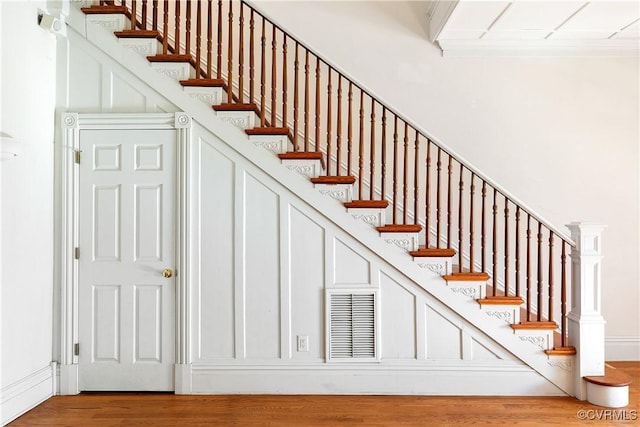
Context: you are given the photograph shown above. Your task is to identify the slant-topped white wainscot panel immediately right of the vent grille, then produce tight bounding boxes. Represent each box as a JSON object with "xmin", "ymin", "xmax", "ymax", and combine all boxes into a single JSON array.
[{"xmin": 380, "ymin": 274, "xmax": 416, "ymax": 359}]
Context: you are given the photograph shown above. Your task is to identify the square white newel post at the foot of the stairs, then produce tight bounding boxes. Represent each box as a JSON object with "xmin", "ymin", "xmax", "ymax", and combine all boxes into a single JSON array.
[{"xmin": 567, "ymin": 222, "xmax": 606, "ymax": 400}]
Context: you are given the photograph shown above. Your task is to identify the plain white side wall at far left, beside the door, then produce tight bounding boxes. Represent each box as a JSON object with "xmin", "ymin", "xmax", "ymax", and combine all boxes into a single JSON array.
[{"xmin": 0, "ymin": 2, "xmax": 55, "ymax": 423}]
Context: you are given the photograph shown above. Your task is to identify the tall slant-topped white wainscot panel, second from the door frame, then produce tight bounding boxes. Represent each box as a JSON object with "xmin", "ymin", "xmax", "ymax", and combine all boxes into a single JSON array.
[{"xmin": 245, "ymin": 173, "xmax": 280, "ymax": 359}]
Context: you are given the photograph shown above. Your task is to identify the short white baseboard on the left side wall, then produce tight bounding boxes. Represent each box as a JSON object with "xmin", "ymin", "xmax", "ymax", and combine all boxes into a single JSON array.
[{"xmin": 0, "ymin": 364, "xmax": 55, "ymax": 425}]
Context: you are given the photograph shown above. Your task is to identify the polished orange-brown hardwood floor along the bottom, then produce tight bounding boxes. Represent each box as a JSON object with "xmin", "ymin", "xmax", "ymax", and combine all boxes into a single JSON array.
[{"xmin": 9, "ymin": 362, "xmax": 640, "ymax": 427}]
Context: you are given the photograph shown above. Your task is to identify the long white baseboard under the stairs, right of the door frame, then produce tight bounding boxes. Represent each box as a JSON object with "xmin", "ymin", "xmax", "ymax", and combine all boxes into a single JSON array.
[{"xmin": 191, "ymin": 364, "xmax": 566, "ymax": 396}]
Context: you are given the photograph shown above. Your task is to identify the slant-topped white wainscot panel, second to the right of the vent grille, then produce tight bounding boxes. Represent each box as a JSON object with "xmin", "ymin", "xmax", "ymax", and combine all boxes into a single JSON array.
[{"xmin": 426, "ymin": 305, "xmax": 462, "ymax": 360}]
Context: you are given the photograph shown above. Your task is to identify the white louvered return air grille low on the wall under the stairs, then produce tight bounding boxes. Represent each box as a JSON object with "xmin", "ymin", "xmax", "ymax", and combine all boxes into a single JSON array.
[{"xmin": 329, "ymin": 293, "xmax": 376, "ymax": 359}]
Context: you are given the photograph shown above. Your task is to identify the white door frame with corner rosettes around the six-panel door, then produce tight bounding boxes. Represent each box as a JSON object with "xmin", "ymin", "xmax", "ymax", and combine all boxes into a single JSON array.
[{"xmin": 57, "ymin": 112, "xmax": 191, "ymax": 394}]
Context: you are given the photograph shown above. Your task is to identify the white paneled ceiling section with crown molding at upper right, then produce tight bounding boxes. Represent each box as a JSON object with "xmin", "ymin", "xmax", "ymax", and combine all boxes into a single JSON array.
[{"xmin": 427, "ymin": 0, "xmax": 640, "ymax": 56}]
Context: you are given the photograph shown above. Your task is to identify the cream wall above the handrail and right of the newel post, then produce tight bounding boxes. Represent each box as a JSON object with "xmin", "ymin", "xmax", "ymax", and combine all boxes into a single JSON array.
[{"xmin": 253, "ymin": 1, "xmax": 640, "ymax": 360}]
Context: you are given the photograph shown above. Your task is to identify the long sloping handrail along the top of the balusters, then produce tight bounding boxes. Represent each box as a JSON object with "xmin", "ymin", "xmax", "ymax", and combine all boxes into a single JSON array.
[{"xmin": 240, "ymin": 0, "xmax": 576, "ymax": 247}]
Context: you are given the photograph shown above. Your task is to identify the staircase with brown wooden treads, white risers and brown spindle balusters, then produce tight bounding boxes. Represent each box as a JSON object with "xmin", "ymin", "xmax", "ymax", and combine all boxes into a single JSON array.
[{"xmin": 69, "ymin": 0, "xmax": 620, "ymax": 404}]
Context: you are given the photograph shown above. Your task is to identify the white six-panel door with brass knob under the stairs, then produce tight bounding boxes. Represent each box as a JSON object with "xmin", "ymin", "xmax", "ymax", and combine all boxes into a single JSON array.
[{"xmin": 78, "ymin": 129, "xmax": 176, "ymax": 391}]
